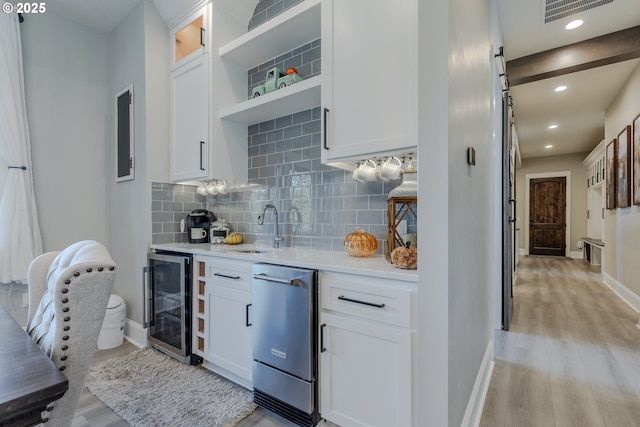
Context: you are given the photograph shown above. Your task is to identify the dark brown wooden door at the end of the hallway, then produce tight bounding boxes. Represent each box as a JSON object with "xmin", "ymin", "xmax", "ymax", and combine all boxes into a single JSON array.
[{"xmin": 529, "ymin": 177, "xmax": 567, "ymax": 256}]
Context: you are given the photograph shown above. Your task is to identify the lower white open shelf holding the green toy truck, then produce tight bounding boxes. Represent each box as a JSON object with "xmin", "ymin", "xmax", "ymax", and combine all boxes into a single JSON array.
[{"xmin": 220, "ymin": 75, "xmax": 322, "ymax": 125}]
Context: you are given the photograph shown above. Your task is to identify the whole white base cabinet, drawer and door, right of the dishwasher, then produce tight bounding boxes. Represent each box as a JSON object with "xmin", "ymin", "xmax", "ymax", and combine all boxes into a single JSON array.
[{"xmin": 319, "ymin": 272, "xmax": 413, "ymax": 427}]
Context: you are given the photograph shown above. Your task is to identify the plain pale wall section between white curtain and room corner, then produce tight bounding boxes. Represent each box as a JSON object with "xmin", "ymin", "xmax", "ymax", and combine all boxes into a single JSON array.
[{"xmin": 20, "ymin": 11, "xmax": 112, "ymax": 251}]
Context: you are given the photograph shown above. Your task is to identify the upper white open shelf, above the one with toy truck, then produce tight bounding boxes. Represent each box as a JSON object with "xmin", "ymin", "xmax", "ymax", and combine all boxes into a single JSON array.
[{"xmin": 220, "ymin": 0, "xmax": 321, "ymax": 68}]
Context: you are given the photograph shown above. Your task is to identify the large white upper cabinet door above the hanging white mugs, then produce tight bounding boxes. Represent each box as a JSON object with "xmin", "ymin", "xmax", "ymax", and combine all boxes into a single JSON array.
[{"xmin": 322, "ymin": 0, "xmax": 418, "ymax": 163}]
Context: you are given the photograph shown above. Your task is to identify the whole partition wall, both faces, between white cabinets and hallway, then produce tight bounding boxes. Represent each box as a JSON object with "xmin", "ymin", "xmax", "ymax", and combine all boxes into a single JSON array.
[{"xmin": 415, "ymin": 0, "xmax": 497, "ymax": 426}]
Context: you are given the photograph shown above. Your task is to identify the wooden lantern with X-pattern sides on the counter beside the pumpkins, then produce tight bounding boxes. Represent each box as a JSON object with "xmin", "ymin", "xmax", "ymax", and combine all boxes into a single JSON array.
[{"xmin": 385, "ymin": 169, "xmax": 418, "ymax": 268}]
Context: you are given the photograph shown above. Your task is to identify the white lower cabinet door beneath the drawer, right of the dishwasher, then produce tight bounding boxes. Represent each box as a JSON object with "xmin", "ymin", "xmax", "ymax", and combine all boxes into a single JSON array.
[{"xmin": 320, "ymin": 313, "xmax": 411, "ymax": 427}]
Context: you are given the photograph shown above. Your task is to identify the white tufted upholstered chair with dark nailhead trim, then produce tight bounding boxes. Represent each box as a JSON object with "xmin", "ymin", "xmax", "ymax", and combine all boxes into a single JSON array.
[{"xmin": 27, "ymin": 240, "xmax": 116, "ymax": 427}]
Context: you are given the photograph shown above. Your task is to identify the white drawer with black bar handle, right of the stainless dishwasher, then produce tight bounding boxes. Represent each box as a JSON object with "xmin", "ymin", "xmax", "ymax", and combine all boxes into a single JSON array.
[{"xmin": 319, "ymin": 272, "xmax": 413, "ymax": 328}]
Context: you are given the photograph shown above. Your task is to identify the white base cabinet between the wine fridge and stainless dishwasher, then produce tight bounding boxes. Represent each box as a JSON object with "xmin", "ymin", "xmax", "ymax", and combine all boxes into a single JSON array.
[{"xmin": 197, "ymin": 257, "xmax": 252, "ymax": 388}]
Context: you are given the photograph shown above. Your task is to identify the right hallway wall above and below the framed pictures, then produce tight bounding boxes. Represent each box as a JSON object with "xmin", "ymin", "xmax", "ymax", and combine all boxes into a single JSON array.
[{"xmin": 603, "ymin": 65, "xmax": 640, "ymax": 309}]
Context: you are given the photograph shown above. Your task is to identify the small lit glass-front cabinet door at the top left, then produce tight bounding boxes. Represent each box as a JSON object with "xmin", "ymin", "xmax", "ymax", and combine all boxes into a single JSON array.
[{"xmin": 171, "ymin": 6, "xmax": 210, "ymax": 68}]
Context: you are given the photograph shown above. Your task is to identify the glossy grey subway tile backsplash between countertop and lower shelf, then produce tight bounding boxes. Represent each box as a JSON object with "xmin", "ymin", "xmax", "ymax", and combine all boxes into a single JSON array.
[{"xmin": 152, "ymin": 107, "xmax": 416, "ymax": 253}]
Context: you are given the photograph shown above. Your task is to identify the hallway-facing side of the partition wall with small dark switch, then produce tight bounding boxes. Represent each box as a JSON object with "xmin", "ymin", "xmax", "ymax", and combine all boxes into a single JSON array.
[{"xmin": 448, "ymin": 0, "xmax": 498, "ymax": 426}]
